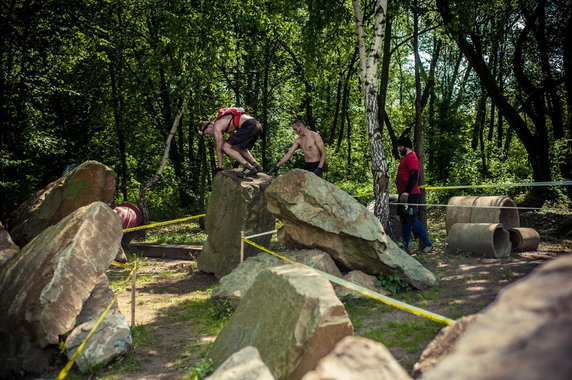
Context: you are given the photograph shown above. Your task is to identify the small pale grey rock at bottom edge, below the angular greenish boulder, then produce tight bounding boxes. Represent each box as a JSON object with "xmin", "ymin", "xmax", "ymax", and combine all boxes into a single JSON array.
[{"xmin": 207, "ymin": 346, "xmax": 274, "ymax": 380}]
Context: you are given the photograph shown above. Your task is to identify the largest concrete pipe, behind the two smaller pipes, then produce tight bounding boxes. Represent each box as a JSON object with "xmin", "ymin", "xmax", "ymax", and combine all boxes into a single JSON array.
[{"xmin": 445, "ymin": 195, "xmax": 520, "ymax": 232}]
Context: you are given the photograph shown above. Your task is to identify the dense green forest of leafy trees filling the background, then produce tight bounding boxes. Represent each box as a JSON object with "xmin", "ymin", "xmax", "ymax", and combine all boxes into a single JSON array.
[{"xmin": 0, "ymin": 0, "xmax": 572, "ymax": 223}]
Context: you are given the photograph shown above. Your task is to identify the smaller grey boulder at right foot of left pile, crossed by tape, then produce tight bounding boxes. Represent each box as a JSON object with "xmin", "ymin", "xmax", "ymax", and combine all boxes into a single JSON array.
[{"xmin": 66, "ymin": 273, "xmax": 132, "ymax": 373}]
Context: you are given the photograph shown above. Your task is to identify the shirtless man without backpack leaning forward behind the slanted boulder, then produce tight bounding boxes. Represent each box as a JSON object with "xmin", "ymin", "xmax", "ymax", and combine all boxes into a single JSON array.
[{"xmin": 268, "ymin": 119, "xmax": 326, "ymax": 177}]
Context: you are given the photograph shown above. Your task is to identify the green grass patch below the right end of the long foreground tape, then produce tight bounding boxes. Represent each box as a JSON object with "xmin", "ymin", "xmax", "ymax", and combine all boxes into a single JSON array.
[{"xmin": 362, "ymin": 320, "xmax": 444, "ymax": 354}]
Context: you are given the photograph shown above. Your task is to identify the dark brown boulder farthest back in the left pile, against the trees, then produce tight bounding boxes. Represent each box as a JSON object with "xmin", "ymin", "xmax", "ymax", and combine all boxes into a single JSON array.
[{"xmin": 7, "ymin": 161, "xmax": 115, "ymax": 247}]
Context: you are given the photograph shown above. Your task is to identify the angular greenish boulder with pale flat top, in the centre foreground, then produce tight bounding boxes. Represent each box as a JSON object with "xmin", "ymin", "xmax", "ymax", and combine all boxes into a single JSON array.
[{"xmin": 209, "ymin": 265, "xmax": 352, "ymax": 380}]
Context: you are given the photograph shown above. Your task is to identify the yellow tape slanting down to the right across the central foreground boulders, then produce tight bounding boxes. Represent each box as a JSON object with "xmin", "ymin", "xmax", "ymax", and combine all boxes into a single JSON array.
[{"xmin": 242, "ymin": 238, "xmax": 455, "ymax": 325}]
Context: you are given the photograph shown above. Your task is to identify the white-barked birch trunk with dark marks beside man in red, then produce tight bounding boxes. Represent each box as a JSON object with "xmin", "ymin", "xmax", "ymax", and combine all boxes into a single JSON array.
[{"xmin": 352, "ymin": 0, "xmax": 392, "ymax": 236}]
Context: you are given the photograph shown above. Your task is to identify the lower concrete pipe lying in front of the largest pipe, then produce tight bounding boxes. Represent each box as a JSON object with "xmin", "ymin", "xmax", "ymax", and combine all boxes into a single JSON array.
[{"xmin": 447, "ymin": 223, "xmax": 511, "ymax": 258}]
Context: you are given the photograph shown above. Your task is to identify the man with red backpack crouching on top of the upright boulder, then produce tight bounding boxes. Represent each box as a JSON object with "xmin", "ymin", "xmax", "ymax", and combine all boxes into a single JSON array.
[{"xmin": 200, "ymin": 108, "xmax": 262, "ymax": 178}]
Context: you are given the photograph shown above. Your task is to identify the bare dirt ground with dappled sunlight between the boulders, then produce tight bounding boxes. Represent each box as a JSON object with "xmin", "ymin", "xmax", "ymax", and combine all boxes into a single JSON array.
[{"xmin": 91, "ymin": 215, "xmax": 572, "ymax": 379}]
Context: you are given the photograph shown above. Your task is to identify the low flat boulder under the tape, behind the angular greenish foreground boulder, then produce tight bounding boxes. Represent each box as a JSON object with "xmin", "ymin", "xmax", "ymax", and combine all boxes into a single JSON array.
[{"xmin": 212, "ymin": 249, "xmax": 342, "ymax": 308}]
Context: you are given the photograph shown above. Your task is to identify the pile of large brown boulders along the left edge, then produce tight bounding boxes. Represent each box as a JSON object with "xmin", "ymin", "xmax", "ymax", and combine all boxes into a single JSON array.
[{"xmin": 0, "ymin": 161, "xmax": 131, "ymax": 377}]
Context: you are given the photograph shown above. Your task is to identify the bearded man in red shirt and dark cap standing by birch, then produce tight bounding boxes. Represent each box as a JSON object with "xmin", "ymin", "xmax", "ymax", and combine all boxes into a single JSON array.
[{"xmin": 395, "ymin": 136, "xmax": 433, "ymax": 253}]
